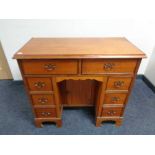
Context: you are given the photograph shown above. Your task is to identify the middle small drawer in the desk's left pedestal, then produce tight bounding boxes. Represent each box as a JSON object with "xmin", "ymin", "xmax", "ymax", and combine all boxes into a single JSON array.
[{"xmin": 31, "ymin": 94, "xmax": 55, "ymax": 105}]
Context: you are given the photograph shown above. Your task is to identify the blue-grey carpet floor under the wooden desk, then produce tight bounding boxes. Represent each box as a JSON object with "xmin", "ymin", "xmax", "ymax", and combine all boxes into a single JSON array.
[{"xmin": 0, "ymin": 80, "xmax": 155, "ymax": 135}]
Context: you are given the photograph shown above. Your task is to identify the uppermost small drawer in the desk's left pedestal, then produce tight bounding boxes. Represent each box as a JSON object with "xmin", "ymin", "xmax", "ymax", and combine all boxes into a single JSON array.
[{"xmin": 27, "ymin": 78, "xmax": 52, "ymax": 91}]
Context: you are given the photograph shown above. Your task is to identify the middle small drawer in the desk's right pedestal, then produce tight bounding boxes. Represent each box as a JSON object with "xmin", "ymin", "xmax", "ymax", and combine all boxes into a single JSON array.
[{"xmin": 104, "ymin": 93, "xmax": 127, "ymax": 104}]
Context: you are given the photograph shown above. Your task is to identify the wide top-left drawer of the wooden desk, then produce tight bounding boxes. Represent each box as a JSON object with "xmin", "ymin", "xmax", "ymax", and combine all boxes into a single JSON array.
[{"xmin": 22, "ymin": 60, "xmax": 78, "ymax": 74}]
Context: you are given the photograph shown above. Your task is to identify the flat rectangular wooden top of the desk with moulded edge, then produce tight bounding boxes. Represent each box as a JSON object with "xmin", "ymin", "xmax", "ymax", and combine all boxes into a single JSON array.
[{"xmin": 14, "ymin": 38, "xmax": 146, "ymax": 59}]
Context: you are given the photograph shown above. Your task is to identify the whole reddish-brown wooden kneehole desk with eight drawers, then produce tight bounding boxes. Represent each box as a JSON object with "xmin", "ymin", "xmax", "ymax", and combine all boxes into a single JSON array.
[{"xmin": 14, "ymin": 38, "xmax": 146, "ymax": 127}]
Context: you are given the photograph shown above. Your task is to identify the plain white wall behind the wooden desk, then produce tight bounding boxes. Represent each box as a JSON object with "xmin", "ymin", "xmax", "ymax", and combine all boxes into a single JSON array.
[{"xmin": 0, "ymin": 20, "xmax": 155, "ymax": 80}]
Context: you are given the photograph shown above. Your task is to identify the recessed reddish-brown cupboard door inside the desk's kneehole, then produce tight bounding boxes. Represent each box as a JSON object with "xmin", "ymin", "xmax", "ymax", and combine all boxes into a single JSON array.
[{"xmin": 60, "ymin": 80, "xmax": 97, "ymax": 107}]
